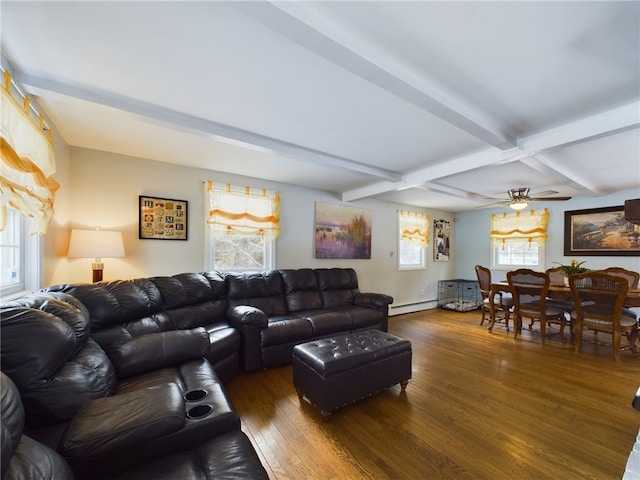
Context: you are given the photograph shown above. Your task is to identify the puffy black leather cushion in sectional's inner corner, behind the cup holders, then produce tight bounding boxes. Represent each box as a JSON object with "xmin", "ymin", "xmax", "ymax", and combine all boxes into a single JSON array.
[{"xmin": 107, "ymin": 327, "xmax": 209, "ymax": 378}]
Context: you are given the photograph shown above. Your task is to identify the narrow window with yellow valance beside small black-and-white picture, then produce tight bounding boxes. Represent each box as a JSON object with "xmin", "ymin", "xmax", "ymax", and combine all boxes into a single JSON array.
[{"xmin": 398, "ymin": 210, "xmax": 429, "ymax": 270}]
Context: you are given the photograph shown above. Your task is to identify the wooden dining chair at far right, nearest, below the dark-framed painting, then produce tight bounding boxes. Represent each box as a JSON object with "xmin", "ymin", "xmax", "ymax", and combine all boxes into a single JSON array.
[{"xmin": 569, "ymin": 271, "xmax": 638, "ymax": 362}]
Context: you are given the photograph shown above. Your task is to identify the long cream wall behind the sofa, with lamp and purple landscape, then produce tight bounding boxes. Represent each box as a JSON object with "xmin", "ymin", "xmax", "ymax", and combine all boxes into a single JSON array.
[{"xmin": 45, "ymin": 148, "xmax": 456, "ymax": 310}]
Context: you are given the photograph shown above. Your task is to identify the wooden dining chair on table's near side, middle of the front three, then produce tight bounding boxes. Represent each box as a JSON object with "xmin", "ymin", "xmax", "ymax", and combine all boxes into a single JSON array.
[{"xmin": 507, "ymin": 268, "xmax": 567, "ymax": 343}]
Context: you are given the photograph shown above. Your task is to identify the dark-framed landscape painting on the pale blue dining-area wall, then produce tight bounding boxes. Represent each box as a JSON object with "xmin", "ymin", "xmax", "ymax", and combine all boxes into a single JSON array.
[{"xmin": 564, "ymin": 206, "xmax": 640, "ymax": 256}]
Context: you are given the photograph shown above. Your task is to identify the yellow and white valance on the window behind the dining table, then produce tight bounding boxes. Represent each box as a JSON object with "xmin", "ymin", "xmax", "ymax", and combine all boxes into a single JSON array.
[{"xmin": 491, "ymin": 208, "xmax": 549, "ymax": 246}]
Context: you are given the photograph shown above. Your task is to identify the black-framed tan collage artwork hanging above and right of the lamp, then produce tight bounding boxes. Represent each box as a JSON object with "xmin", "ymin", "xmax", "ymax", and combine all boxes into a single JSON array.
[{"xmin": 138, "ymin": 195, "xmax": 189, "ymax": 240}]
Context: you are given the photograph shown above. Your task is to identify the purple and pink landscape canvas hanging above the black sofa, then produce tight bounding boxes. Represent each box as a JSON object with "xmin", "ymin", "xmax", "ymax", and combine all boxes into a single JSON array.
[{"xmin": 315, "ymin": 202, "xmax": 371, "ymax": 259}]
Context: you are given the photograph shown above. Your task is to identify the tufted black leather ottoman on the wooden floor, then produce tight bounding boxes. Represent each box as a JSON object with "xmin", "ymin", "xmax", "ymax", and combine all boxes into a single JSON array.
[{"xmin": 293, "ymin": 330, "xmax": 411, "ymax": 418}]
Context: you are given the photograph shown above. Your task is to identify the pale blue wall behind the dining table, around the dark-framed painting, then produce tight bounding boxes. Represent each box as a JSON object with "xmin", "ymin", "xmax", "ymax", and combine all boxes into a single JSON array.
[{"xmin": 455, "ymin": 190, "xmax": 640, "ymax": 280}]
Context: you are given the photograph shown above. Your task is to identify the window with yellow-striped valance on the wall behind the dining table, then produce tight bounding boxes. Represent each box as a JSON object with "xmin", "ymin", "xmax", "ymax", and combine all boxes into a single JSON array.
[{"xmin": 491, "ymin": 209, "xmax": 549, "ymax": 270}]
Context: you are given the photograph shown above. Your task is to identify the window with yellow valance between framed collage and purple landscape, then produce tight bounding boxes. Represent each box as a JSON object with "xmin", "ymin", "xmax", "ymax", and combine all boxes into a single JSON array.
[{"xmin": 206, "ymin": 181, "xmax": 280, "ymax": 271}]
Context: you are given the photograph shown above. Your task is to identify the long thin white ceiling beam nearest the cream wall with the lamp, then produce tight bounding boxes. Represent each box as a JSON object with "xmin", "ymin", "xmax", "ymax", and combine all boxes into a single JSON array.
[{"xmin": 15, "ymin": 72, "xmax": 402, "ymax": 181}]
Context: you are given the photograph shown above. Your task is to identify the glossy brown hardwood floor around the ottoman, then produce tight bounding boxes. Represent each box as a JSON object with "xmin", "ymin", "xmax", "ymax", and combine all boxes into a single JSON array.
[{"xmin": 226, "ymin": 309, "xmax": 640, "ymax": 480}]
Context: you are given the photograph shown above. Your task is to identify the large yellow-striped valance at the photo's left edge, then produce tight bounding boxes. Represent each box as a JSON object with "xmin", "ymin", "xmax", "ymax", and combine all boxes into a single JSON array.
[{"xmin": 0, "ymin": 72, "xmax": 59, "ymax": 235}]
